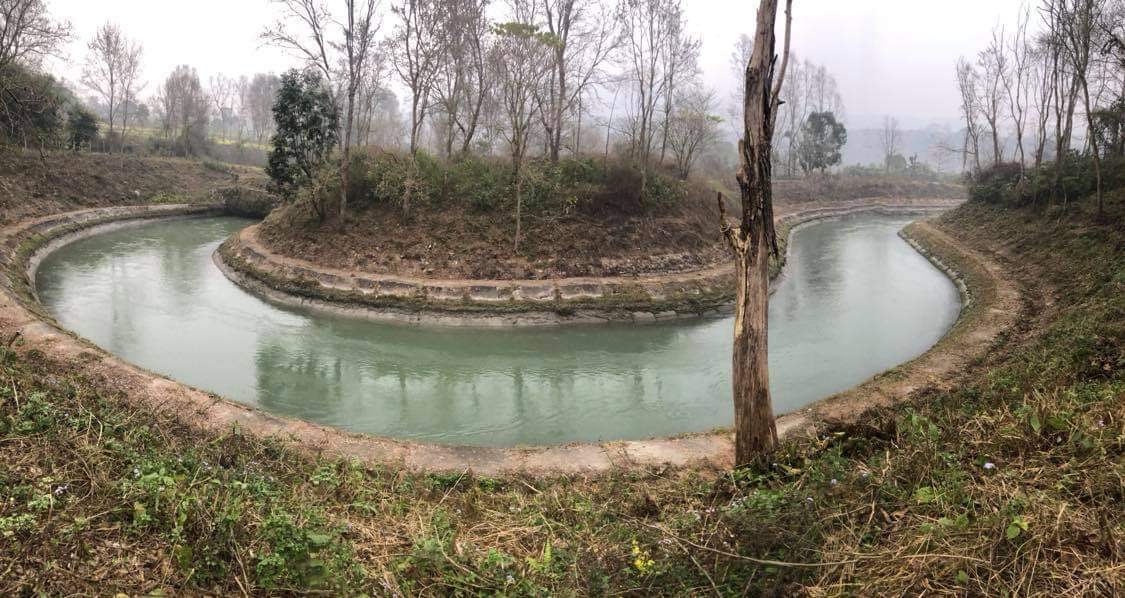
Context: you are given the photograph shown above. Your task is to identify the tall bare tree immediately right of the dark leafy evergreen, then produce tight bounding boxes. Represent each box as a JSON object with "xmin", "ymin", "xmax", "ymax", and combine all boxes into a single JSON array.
[{"xmin": 262, "ymin": 0, "xmax": 383, "ymax": 219}]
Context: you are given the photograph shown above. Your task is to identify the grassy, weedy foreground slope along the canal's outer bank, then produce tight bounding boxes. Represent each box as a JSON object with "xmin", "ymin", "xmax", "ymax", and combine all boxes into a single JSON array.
[{"xmin": 0, "ymin": 191, "xmax": 1125, "ymax": 596}]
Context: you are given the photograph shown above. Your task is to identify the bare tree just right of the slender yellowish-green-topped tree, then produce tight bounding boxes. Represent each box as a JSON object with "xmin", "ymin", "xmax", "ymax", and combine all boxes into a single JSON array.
[{"xmin": 537, "ymin": 0, "xmax": 621, "ymax": 161}]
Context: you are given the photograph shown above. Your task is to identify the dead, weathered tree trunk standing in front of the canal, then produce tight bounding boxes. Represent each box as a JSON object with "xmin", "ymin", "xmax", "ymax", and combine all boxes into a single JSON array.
[{"xmin": 719, "ymin": 0, "xmax": 793, "ymax": 466}]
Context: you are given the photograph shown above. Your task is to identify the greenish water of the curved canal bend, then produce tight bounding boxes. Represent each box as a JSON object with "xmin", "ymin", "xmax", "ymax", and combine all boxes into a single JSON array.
[{"xmin": 36, "ymin": 212, "xmax": 960, "ymax": 446}]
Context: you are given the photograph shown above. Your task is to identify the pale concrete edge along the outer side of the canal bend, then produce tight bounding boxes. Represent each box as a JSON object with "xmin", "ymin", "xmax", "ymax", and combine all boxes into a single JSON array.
[{"xmin": 0, "ymin": 201, "xmax": 1019, "ymax": 475}]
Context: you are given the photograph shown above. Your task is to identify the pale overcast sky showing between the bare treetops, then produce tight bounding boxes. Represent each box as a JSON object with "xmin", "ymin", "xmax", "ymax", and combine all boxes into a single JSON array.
[{"xmin": 48, "ymin": 0, "xmax": 1022, "ymax": 127}]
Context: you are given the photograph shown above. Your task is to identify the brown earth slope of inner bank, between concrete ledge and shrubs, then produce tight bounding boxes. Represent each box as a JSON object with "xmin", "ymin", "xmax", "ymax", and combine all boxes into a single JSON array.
[{"xmin": 260, "ymin": 178, "xmax": 963, "ymax": 280}]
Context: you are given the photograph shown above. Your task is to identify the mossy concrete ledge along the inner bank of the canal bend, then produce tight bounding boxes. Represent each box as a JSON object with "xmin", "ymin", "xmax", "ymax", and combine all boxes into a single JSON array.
[{"xmin": 214, "ymin": 200, "xmax": 957, "ymax": 327}]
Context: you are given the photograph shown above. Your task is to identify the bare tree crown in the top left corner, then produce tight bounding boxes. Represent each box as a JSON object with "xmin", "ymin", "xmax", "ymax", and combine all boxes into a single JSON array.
[{"xmin": 0, "ymin": 0, "xmax": 71, "ymax": 69}]
